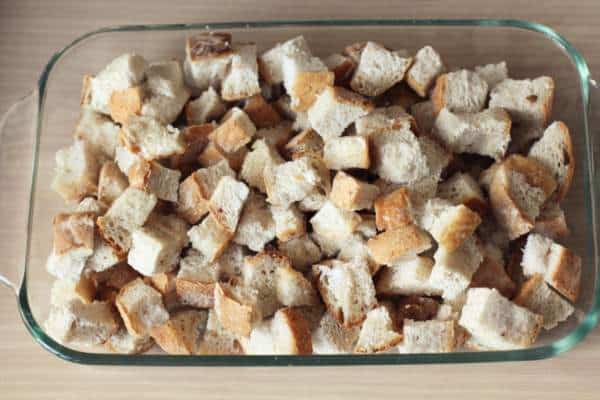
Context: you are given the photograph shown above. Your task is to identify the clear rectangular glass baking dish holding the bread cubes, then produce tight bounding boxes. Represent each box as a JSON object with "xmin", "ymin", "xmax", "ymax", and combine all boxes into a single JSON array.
[{"xmin": 0, "ymin": 20, "xmax": 600, "ymax": 365}]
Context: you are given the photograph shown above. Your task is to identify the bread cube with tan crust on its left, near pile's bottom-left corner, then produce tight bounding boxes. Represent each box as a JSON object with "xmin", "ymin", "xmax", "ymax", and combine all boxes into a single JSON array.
[{"xmin": 115, "ymin": 278, "xmax": 169, "ymax": 337}]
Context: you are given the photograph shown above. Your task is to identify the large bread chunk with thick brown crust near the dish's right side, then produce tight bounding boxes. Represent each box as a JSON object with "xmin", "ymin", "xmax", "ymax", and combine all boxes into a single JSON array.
[{"xmin": 489, "ymin": 155, "xmax": 556, "ymax": 240}]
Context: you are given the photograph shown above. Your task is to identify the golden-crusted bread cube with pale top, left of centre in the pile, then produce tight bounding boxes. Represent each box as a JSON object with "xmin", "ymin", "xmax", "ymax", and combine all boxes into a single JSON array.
[{"xmin": 177, "ymin": 161, "xmax": 235, "ymax": 224}]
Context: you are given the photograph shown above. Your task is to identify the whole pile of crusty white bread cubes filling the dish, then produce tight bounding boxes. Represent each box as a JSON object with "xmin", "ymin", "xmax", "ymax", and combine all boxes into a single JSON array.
[{"xmin": 46, "ymin": 32, "xmax": 581, "ymax": 355}]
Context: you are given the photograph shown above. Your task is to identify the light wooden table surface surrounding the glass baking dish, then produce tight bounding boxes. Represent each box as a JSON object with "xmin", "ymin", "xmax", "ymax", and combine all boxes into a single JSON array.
[{"xmin": 0, "ymin": 0, "xmax": 600, "ymax": 400}]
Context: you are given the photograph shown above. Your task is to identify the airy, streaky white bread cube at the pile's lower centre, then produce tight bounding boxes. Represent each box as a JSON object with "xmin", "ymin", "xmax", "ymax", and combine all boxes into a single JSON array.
[{"xmin": 313, "ymin": 260, "xmax": 377, "ymax": 327}]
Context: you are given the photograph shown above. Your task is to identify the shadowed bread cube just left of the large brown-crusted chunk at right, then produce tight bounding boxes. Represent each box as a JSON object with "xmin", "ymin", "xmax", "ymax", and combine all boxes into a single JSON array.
[{"xmin": 437, "ymin": 172, "xmax": 487, "ymax": 215}]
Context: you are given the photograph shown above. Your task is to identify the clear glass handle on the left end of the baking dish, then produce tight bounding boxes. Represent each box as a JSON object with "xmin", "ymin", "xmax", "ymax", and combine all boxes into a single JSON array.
[{"xmin": 0, "ymin": 89, "xmax": 38, "ymax": 295}]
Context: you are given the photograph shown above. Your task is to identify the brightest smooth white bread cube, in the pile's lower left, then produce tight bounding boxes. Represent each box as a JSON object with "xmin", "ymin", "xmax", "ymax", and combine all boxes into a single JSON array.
[{"xmin": 127, "ymin": 215, "xmax": 188, "ymax": 276}]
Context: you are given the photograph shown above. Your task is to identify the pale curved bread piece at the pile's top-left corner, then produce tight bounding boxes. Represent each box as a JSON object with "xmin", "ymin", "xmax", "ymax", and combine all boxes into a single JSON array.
[{"xmin": 88, "ymin": 54, "xmax": 147, "ymax": 114}]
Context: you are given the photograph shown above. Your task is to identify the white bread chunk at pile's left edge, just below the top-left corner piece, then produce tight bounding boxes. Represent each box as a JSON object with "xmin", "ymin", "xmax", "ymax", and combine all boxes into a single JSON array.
[{"xmin": 73, "ymin": 107, "xmax": 119, "ymax": 159}]
